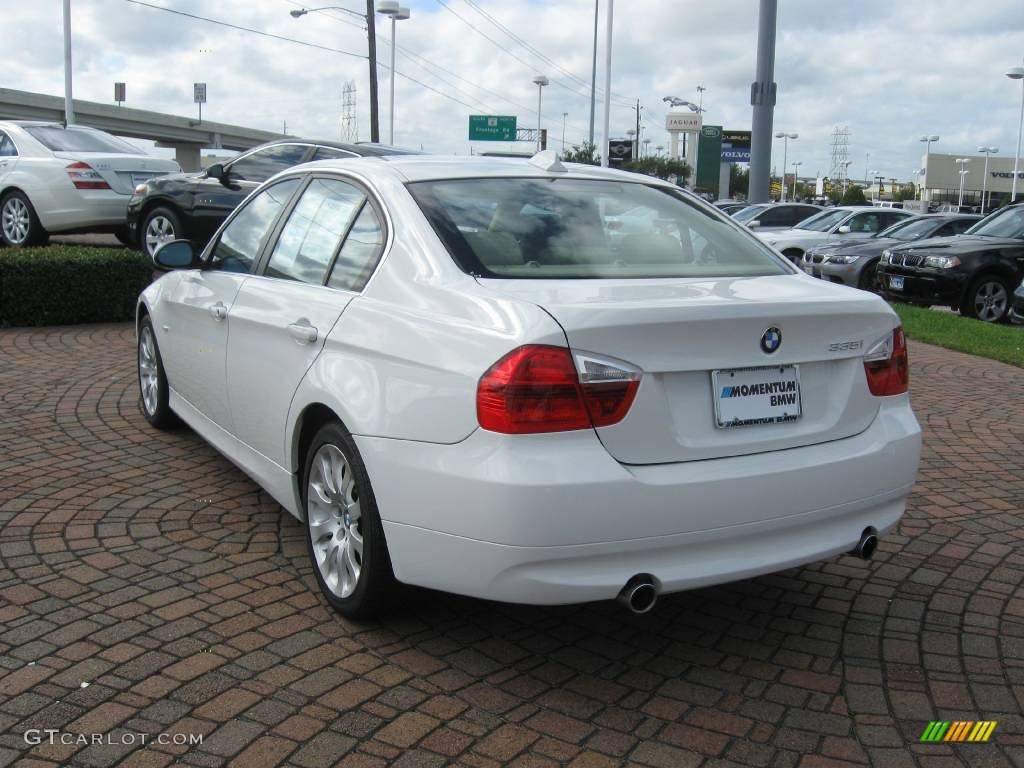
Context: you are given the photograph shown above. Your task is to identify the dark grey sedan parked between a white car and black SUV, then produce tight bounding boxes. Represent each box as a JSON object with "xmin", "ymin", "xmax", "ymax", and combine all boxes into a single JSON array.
[{"xmin": 804, "ymin": 213, "xmax": 981, "ymax": 291}]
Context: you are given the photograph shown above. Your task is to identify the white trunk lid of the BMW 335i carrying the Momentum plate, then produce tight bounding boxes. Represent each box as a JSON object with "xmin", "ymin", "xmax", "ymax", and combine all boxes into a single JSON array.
[{"xmin": 478, "ymin": 275, "xmax": 898, "ymax": 464}]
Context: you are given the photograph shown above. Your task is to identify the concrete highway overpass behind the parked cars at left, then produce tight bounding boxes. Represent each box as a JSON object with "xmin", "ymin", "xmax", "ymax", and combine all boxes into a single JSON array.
[{"xmin": 0, "ymin": 88, "xmax": 282, "ymax": 171}]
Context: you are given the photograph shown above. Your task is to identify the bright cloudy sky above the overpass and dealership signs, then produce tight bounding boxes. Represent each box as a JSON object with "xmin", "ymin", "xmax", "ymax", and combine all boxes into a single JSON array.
[{"xmin": 6, "ymin": 0, "xmax": 1024, "ymax": 178}]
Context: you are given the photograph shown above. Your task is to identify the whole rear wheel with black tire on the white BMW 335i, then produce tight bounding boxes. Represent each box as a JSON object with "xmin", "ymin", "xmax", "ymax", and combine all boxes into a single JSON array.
[{"xmin": 302, "ymin": 421, "xmax": 394, "ymax": 618}]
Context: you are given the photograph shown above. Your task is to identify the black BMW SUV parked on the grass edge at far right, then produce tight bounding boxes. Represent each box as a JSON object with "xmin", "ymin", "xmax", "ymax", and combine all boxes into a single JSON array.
[{"xmin": 878, "ymin": 204, "xmax": 1024, "ymax": 323}]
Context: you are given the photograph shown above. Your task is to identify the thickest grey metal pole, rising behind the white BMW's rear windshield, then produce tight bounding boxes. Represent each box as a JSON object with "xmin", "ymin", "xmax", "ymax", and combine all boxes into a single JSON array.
[{"xmin": 746, "ymin": 0, "xmax": 785, "ymax": 203}]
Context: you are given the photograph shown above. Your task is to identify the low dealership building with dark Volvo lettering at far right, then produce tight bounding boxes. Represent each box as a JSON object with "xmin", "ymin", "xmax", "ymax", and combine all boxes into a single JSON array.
[{"xmin": 918, "ymin": 153, "xmax": 1024, "ymax": 209}]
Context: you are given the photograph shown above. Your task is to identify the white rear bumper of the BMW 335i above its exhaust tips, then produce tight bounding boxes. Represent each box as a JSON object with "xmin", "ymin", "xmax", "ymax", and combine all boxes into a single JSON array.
[{"xmin": 356, "ymin": 395, "xmax": 921, "ymax": 604}]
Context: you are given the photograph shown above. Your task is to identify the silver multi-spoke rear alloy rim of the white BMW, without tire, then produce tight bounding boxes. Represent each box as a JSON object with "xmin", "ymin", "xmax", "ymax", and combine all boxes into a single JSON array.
[{"xmin": 306, "ymin": 443, "xmax": 362, "ymax": 598}]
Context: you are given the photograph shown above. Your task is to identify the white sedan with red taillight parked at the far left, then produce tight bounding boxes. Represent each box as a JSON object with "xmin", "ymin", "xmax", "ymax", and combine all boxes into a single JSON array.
[{"xmin": 0, "ymin": 120, "xmax": 181, "ymax": 246}]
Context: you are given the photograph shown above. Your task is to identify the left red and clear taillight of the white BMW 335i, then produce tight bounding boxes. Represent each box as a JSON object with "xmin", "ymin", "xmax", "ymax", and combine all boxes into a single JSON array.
[{"xmin": 476, "ymin": 345, "xmax": 640, "ymax": 434}]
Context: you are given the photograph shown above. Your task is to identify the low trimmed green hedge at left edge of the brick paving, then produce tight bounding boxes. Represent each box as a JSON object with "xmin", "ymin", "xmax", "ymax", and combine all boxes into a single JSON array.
[{"xmin": 0, "ymin": 246, "xmax": 154, "ymax": 328}]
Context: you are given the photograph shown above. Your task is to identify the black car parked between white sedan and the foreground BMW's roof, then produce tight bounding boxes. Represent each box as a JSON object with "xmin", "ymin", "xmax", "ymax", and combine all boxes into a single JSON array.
[{"xmin": 128, "ymin": 138, "xmax": 410, "ymax": 257}]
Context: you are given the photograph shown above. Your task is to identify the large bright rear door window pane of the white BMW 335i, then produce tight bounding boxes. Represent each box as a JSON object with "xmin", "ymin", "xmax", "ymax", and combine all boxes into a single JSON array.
[{"xmin": 264, "ymin": 178, "xmax": 367, "ymax": 286}]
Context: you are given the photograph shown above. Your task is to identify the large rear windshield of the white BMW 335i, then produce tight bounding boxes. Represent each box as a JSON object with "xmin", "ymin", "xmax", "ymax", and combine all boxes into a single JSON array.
[{"xmin": 409, "ymin": 178, "xmax": 791, "ymax": 279}]
